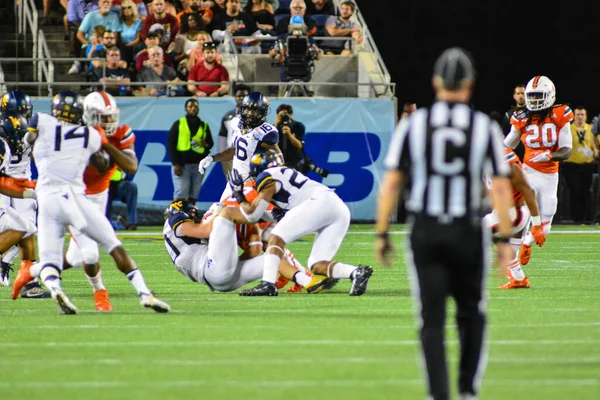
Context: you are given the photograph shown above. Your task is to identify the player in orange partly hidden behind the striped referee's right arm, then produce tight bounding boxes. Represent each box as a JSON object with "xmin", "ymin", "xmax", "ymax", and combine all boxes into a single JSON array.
[{"xmin": 483, "ymin": 149, "xmax": 546, "ymax": 289}]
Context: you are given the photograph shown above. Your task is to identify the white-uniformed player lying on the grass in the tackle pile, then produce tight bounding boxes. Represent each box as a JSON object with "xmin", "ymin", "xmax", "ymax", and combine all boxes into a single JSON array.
[{"xmin": 163, "ymin": 201, "xmax": 330, "ymax": 293}]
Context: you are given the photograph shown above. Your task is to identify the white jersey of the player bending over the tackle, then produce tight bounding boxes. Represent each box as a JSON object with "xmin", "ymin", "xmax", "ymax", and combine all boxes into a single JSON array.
[{"xmin": 255, "ymin": 167, "xmax": 333, "ymax": 210}]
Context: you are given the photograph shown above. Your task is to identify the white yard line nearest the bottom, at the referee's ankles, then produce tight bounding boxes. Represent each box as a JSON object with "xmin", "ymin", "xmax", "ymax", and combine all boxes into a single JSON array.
[{"xmin": 0, "ymin": 378, "xmax": 600, "ymax": 389}]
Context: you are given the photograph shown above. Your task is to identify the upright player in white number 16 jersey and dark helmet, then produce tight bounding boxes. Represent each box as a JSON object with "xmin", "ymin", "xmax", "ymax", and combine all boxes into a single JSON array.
[{"xmin": 198, "ymin": 92, "xmax": 281, "ymax": 201}]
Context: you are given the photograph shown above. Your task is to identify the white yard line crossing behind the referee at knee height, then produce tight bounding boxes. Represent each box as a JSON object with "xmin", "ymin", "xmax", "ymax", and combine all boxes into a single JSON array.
[{"xmin": 0, "ymin": 339, "xmax": 600, "ymax": 348}]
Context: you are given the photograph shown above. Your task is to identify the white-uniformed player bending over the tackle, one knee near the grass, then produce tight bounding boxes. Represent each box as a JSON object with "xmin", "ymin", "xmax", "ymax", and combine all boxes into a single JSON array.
[{"xmin": 229, "ymin": 152, "xmax": 373, "ymax": 296}]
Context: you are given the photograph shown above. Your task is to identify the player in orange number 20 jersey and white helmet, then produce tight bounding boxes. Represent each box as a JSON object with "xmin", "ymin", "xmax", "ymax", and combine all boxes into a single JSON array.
[{"xmin": 504, "ymin": 76, "xmax": 573, "ymax": 265}]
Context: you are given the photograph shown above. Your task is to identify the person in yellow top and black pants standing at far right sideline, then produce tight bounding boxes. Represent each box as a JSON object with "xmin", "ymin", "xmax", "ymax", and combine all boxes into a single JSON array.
[{"xmin": 559, "ymin": 106, "xmax": 598, "ymax": 224}]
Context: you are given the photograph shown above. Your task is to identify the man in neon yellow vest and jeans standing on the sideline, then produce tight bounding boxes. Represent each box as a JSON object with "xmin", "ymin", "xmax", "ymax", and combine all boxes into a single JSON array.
[{"xmin": 167, "ymin": 99, "xmax": 214, "ymax": 204}]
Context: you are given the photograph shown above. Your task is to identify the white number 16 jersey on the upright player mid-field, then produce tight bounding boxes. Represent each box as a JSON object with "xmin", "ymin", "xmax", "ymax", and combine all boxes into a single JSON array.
[{"xmin": 231, "ymin": 116, "xmax": 279, "ymax": 180}]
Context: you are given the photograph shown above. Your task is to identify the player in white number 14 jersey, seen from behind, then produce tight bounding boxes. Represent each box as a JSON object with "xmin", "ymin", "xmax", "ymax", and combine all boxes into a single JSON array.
[{"xmin": 13, "ymin": 91, "xmax": 170, "ymax": 314}]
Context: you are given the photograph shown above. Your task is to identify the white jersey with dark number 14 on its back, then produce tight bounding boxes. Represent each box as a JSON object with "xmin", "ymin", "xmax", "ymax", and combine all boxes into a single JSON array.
[{"xmin": 29, "ymin": 113, "xmax": 102, "ymax": 193}]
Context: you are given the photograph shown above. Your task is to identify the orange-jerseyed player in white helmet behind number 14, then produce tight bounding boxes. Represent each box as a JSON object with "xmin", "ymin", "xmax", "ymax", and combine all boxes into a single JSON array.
[{"xmin": 64, "ymin": 91, "xmax": 138, "ymax": 311}]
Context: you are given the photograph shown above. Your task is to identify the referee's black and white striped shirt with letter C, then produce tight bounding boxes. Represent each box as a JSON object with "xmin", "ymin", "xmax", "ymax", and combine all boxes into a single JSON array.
[{"xmin": 384, "ymin": 101, "xmax": 510, "ymax": 224}]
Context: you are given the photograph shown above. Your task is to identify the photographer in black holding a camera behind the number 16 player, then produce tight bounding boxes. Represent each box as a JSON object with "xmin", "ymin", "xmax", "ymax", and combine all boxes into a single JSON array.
[{"xmin": 275, "ymin": 104, "xmax": 306, "ymax": 168}]
